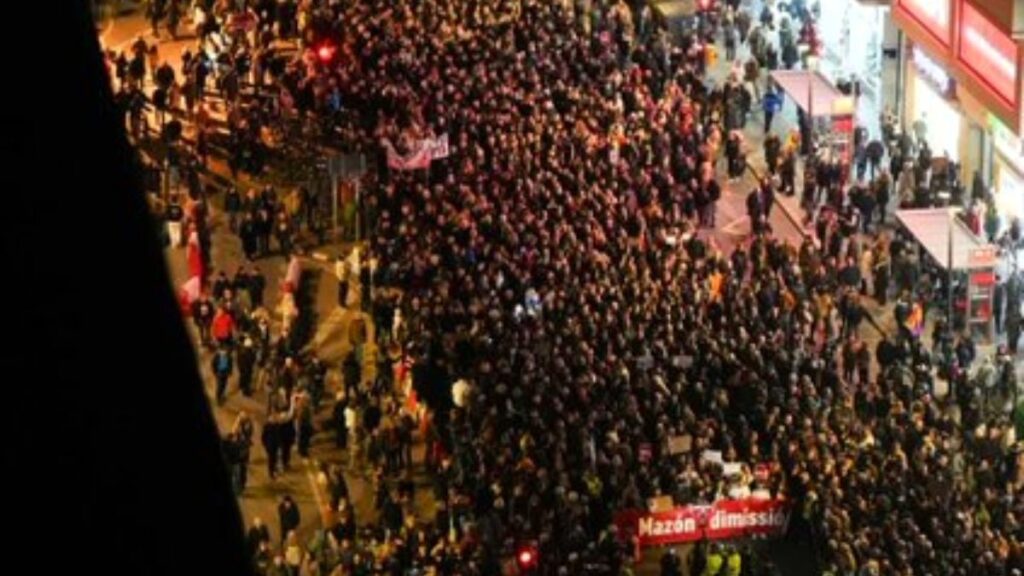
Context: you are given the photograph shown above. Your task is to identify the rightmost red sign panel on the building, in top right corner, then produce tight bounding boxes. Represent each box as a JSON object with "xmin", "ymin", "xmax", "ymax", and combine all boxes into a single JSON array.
[{"xmin": 959, "ymin": 3, "xmax": 1018, "ymax": 106}]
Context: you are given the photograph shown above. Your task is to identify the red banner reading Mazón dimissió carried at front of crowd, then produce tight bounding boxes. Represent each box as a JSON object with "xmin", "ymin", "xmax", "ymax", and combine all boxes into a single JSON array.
[{"xmin": 615, "ymin": 498, "xmax": 790, "ymax": 547}]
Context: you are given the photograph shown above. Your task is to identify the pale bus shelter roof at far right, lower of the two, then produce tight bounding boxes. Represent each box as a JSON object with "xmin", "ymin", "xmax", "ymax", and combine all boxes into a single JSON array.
[{"xmin": 896, "ymin": 208, "xmax": 992, "ymax": 270}]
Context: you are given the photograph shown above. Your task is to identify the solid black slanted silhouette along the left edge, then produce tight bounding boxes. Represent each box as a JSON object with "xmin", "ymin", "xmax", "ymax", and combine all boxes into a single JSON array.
[{"xmin": 0, "ymin": 0, "xmax": 251, "ymax": 576}]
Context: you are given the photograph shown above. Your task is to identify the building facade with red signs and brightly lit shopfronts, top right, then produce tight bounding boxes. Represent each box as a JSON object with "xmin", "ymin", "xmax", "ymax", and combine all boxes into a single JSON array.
[{"xmin": 892, "ymin": 0, "xmax": 1024, "ymax": 228}]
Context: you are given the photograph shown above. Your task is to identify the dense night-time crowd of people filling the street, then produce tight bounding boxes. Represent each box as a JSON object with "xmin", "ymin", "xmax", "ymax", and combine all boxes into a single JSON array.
[{"xmin": 113, "ymin": 0, "xmax": 1024, "ymax": 576}]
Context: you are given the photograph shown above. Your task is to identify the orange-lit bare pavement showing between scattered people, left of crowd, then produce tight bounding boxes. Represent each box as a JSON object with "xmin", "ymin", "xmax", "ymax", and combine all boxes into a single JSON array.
[{"xmin": 110, "ymin": 13, "xmax": 435, "ymax": 542}]
